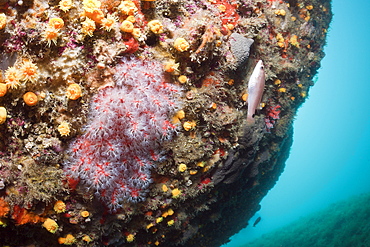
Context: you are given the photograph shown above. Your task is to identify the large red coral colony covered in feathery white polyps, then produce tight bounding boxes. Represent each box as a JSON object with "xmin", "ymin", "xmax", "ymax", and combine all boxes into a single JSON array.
[{"xmin": 64, "ymin": 58, "xmax": 181, "ymax": 210}]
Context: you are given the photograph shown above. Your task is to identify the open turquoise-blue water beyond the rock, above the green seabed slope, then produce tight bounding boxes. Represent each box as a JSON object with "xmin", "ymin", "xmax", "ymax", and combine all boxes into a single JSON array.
[{"xmin": 224, "ymin": 0, "xmax": 370, "ymax": 247}]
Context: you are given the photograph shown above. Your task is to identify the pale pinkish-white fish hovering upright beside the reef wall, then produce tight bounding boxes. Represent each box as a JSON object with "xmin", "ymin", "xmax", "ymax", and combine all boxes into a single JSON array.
[{"xmin": 247, "ymin": 60, "xmax": 265, "ymax": 124}]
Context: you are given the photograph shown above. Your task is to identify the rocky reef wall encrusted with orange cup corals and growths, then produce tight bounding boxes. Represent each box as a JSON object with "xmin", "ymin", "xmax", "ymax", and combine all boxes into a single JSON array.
[{"xmin": 0, "ymin": 0, "xmax": 332, "ymax": 246}]
